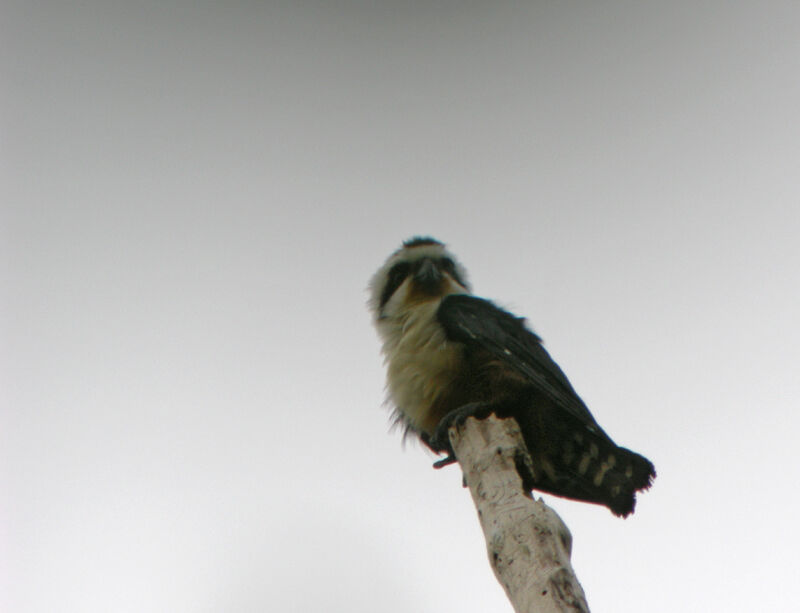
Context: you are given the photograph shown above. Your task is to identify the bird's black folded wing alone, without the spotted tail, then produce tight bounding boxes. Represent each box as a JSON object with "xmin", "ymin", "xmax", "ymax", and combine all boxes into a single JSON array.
[{"xmin": 438, "ymin": 294, "xmax": 604, "ymax": 434}]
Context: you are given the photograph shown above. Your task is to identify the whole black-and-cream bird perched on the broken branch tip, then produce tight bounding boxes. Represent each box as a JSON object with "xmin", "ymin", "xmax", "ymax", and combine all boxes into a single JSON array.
[{"xmin": 368, "ymin": 236, "xmax": 656, "ymax": 517}]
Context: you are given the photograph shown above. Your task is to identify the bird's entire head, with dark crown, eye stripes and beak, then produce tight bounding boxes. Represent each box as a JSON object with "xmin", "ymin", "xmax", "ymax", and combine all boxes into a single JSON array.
[{"xmin": 369, "ymin": 237, "xmax": 469, "ymax": 321}]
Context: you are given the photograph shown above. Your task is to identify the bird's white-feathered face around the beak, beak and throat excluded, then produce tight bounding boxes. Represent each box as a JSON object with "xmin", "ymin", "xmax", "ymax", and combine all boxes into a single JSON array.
[{"xmin": 369, "ymin": 238, "xmax": 469, "ymax": 321}]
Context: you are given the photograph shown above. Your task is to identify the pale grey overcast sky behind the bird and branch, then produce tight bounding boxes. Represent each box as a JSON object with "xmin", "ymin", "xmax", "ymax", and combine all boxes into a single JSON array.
[{"xmin": 0, "ymin": 1, "xmax": 800, "ymax": 613}]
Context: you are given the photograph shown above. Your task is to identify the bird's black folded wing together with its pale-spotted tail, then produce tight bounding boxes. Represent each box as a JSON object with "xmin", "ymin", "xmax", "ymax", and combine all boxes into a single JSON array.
[{"xmin": 438, "ymin": 295, "xmax": 656, "ymax": 517}]
